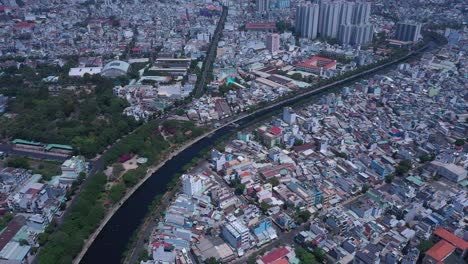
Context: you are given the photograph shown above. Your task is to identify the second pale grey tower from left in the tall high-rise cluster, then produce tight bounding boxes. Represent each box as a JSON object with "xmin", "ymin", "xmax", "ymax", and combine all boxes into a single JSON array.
[{"xmin": 318, "ymin": 1, "xmax": 343, "ymax": 38}]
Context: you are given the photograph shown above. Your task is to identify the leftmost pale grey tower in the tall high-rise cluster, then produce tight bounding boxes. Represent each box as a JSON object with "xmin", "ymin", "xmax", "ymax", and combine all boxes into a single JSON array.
[{"xmin": 296, "ymin": 3, "xmax": 319, "ymax": 39}]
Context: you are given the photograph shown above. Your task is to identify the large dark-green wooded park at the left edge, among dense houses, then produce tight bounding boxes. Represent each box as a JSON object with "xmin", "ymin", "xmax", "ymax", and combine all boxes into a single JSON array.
[{"xmin": 0, "ymin": 64, "xmax": 139, "ymax": 157}]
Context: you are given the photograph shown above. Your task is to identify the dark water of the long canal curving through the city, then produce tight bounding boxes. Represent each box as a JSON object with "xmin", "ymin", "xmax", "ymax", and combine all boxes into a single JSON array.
[{"xmin": 80, "ymin": 42, "xmax": 437, "ymax": 264}]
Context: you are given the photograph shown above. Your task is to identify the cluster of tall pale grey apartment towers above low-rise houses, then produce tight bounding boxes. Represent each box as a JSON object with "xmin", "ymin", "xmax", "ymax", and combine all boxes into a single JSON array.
[{"xmin": 296, "ymin": 0, "xmax": 373, "ymax": 45}]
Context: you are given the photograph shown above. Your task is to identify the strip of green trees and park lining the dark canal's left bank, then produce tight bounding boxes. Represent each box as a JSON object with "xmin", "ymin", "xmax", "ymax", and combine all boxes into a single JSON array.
[{"xmin": 38, "ymin": 121, "xmax": 205, "ymax": 264}]
